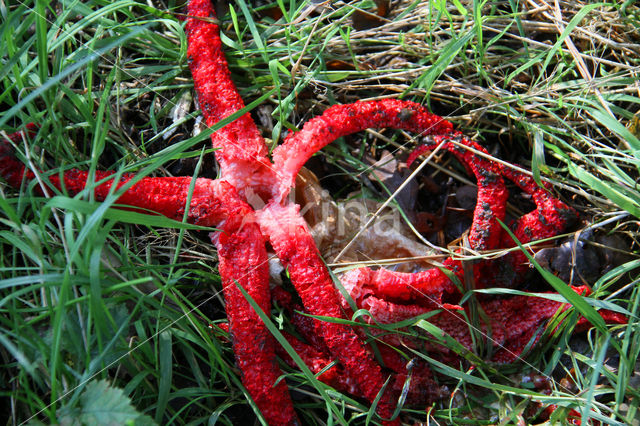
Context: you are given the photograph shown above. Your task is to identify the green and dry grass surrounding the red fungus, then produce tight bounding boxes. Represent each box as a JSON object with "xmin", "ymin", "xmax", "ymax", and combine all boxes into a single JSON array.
[{"xmin": 0, "ymin": 0, "xmax": 640, "ymax": 424}]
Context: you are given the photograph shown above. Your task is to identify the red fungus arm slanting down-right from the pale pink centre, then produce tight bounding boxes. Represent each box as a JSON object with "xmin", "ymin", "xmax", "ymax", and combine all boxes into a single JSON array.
[{"xmin": 256, "ymin": 202, "xmax": 395, "ymax": 424}]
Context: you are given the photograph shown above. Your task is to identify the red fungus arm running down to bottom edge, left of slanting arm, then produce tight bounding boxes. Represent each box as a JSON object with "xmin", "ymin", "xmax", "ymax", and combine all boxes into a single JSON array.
[{"xmin": 216, "ymin": 221, "xmax": 299, "ymax": 425}]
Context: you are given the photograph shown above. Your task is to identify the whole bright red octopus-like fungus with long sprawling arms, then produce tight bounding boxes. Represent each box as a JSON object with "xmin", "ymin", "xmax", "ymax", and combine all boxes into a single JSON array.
[{"xmin": 0, "ymin": 0, "xmax": 626, "ymax": 425}]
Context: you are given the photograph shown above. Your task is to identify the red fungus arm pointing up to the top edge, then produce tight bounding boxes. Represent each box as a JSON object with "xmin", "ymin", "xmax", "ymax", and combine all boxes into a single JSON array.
[{"xmin": 186, "ymin": 0, "xmax": 273, "ymax": 197}]
